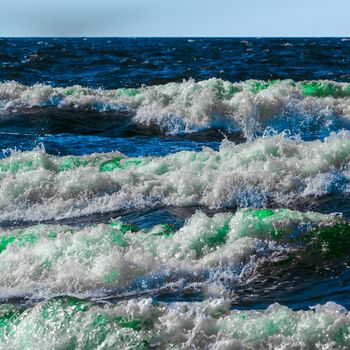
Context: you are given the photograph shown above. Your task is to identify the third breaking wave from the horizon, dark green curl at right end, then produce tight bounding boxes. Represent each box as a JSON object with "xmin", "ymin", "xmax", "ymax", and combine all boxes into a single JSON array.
[{"xmin": 0, "ymin": 209, "xmax": 350, "ymax": 298}]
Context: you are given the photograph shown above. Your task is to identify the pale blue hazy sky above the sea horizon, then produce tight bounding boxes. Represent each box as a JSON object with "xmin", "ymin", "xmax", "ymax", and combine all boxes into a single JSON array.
[{"xmin": 0, "ymin": 0, "xmax": 350, "ymax": 36}]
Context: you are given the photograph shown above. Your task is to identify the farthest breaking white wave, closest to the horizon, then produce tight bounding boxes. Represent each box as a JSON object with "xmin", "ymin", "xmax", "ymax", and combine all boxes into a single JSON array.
[{"xmin": 0, "ymin": 79, "xmax": 350, "ymax": 137}]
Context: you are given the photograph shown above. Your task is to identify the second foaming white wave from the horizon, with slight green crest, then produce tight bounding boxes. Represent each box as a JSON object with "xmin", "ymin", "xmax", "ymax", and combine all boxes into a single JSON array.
[{"xmin": 0, "ymin": 132, "xmax": 350, "ymax": 222}]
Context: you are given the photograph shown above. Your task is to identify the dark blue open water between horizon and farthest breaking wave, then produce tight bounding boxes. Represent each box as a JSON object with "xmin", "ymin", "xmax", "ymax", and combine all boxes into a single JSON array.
[{"xmin": 0, "ymin": 38, "xmax": 350, "ymax": 89}]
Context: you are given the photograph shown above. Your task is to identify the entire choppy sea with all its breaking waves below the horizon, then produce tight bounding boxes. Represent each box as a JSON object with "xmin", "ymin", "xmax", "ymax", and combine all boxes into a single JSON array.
[{"xmin": 0, "ymin": 38, "xmax": 350, "ymax": 349}]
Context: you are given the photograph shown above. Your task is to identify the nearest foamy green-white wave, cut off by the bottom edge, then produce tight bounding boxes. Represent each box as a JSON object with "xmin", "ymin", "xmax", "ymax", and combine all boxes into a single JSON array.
[{"xmin": 0, "ymin": 297, "xmax": 350, "ymax": 350}]
